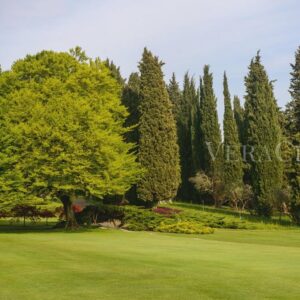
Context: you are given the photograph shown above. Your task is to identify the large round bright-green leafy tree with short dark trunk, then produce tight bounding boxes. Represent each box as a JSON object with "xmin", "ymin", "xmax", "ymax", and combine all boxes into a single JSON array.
[{"xmin": 0, "ymin": 49, "xmax": 140, "ymax": 225}]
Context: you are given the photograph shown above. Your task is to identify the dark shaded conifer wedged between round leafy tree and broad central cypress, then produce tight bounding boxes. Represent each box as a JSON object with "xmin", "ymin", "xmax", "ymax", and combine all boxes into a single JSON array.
[{"xmin": 122, "ymin": 73, "xmax": 140, "ymax": 146}]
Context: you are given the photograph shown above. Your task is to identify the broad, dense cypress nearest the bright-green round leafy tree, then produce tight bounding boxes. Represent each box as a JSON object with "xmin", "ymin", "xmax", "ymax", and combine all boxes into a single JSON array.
[{"xmin": 138, "ymin": 48, "xmax": 180, "ymax": 205}]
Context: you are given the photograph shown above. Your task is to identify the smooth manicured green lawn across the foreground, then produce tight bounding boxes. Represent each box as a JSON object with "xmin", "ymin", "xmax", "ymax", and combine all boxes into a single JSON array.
[{"xmin": 0, "ymin": 229, "xmax": 300, "ymax": 300}]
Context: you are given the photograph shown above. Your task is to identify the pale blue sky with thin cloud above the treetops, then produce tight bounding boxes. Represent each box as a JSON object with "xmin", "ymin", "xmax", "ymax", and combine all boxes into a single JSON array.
[{"xmin": 0, "ymin": 0, "xmax": 300, "ymax": 118}]
